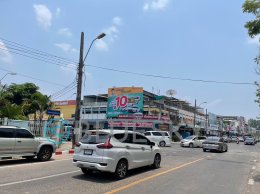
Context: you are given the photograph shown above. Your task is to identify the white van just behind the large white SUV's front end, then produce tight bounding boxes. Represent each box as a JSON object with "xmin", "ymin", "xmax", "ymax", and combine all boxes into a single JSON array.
[{"xmin": 144, "ymin": 131, "xmax": 172, "ymax": 147}]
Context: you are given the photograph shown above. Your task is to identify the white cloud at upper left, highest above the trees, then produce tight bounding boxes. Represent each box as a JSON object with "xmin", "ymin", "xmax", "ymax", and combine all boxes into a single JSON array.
[{"xmin": 33, "ymin": 4, "xmax": 52, "ymax": 30}]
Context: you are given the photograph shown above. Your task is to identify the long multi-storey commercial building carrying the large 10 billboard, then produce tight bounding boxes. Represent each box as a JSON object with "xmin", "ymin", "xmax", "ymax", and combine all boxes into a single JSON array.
[{"xmin": 80, "ymin": 87, "xmax": 206, "ymax": 138}]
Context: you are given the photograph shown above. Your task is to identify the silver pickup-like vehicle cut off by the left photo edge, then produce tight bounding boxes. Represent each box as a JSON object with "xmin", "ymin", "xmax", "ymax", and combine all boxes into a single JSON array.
[{"xmin": 0, "ymin": 126, "xmax": 56, "ymax": 161}]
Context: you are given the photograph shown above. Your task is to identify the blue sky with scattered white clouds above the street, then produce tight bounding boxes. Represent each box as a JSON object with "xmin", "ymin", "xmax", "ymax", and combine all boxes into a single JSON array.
[{"xmin": 0, "ymin": 0, "xmax": 259, "ymax": 119}]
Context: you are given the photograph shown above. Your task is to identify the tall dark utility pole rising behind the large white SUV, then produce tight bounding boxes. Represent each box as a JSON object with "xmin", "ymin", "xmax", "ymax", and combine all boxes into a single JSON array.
[{"xmin": 72, "ymin": 32, "xmax": 84, "ymax": 149}]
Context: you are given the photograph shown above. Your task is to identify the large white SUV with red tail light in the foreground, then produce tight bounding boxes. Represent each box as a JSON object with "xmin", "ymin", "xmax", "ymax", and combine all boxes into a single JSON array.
[{"xmin": 73, "ymin": 130, "xmax": 161, "ymax": 179}]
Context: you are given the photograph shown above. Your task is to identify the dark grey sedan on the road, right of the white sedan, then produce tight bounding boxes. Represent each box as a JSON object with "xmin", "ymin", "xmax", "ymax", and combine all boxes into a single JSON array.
[{"xmin": 202, "ymin": 136, "xmax": 228, "ymax": 152}]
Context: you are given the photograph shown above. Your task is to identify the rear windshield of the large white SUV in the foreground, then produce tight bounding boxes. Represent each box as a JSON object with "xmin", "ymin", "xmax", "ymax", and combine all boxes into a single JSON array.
[{"xmin": 80, "ymin": 133, "xmax": 109, "ymax": 144}]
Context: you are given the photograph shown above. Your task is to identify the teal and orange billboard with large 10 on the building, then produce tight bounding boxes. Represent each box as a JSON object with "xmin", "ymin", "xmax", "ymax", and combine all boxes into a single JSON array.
[{"xmin": 107, "ymin": 87, "xmax": 144, "ymax": 118}]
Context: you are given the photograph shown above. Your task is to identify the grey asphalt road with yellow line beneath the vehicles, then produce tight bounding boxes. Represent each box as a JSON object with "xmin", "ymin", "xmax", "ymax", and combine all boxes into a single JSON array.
[{"xmin": 0, "ymin": 143, "xmax": 260, "ymax": 194}]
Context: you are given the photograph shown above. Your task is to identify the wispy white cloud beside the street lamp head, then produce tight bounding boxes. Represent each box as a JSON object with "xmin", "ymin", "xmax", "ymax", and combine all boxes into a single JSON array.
[{"xmin": 95, "ymin": 17, "xmax": 122, "ymax": 51}]
